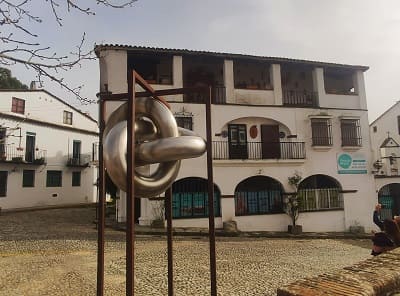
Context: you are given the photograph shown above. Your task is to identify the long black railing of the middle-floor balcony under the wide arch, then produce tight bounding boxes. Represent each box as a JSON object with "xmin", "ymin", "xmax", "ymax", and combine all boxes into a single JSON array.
[{"xmin": 213, "ymin": 141, "xmax": 306, "ymax": 160}]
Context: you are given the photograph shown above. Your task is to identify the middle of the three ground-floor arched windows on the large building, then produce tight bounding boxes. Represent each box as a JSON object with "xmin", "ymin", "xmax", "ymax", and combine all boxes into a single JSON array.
[{"xmin": 235, "ymin": 176, "xmax": 283, "ymax": 216}]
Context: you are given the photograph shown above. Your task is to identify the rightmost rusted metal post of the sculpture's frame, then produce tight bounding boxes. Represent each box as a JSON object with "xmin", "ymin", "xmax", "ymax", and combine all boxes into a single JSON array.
[{"xmin": 206, "ymin": 87, "xmax": 217, "ymax": 296}]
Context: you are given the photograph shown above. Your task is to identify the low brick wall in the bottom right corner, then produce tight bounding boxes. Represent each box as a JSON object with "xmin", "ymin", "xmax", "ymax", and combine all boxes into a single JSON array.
[{"xmin": 277, "ymin": 248, "xmax": 400, "ymax": 296}]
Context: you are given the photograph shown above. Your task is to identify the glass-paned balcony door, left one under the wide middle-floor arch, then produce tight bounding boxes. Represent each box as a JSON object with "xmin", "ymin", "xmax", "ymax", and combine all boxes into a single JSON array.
[{"xmin": 228, "ymin": 124, "xmax": 248, "ymax": 159}]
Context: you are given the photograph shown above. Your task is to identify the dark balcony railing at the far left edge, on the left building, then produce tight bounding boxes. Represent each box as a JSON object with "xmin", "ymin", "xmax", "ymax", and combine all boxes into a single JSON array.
[{"xmin": 0, "ymin": 145, "xmax": 46, "ymax": 165}]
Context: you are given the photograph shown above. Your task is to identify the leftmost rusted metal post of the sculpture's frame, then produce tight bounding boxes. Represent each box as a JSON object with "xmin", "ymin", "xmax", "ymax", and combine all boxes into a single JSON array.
[{"xmin": 97, "ymin": 95, "xmax": 106, "ymax": 296}]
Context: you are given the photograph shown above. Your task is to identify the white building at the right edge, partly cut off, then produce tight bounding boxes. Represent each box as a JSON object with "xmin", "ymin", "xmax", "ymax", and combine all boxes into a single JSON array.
[{"xmin": 370, "ymin": 102, "xmax": 400, "ymax": 218}]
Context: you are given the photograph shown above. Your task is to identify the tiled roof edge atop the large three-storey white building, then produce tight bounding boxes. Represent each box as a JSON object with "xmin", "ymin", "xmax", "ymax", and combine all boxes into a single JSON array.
[{"xmin": 95, "ymin": 44, "xmax": 369, "ymax": 71}]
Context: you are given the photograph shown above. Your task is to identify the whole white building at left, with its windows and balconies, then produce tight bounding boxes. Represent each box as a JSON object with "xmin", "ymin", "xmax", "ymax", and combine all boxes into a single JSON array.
[{"xmin": 0, "ymin": 90, "xmax": 98, "ymax": 209}]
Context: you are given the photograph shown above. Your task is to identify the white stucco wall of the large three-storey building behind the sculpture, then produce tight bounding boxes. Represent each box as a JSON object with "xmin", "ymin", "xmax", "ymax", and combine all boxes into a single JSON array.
[{"xmin": 97, "ymin": 51, "xmax": 376, "ymax": 232}]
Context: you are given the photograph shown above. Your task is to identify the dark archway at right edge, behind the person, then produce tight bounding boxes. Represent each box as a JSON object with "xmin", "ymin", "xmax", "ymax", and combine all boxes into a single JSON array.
[{"xmin": 378, "ymin": 183, "xmax": 400, "ymax": 219}]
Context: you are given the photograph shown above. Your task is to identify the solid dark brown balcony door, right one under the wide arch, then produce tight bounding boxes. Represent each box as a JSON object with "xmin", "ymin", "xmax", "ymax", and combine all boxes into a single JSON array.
[{"xmin": 261, "ymin": 125, "xmax": 281, "ymax": 159}]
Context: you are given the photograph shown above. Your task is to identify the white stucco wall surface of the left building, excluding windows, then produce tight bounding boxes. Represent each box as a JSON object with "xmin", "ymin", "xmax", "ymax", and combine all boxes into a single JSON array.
[{"xmin": 0, "ymin": 91, "xmax": 98, "ymax": 209}]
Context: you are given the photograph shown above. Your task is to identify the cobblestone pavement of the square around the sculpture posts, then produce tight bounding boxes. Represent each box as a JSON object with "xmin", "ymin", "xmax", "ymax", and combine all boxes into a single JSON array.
[{"xmin": 0, "ymin": 208, "xmax": 370, "ymax": 296}]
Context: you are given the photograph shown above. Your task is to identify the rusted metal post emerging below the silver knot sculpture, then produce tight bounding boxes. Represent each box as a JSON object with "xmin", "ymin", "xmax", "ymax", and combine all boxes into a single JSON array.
[{"xmin": 164, "ymin": 187, "xmax": 174, "ymax": 296}]
